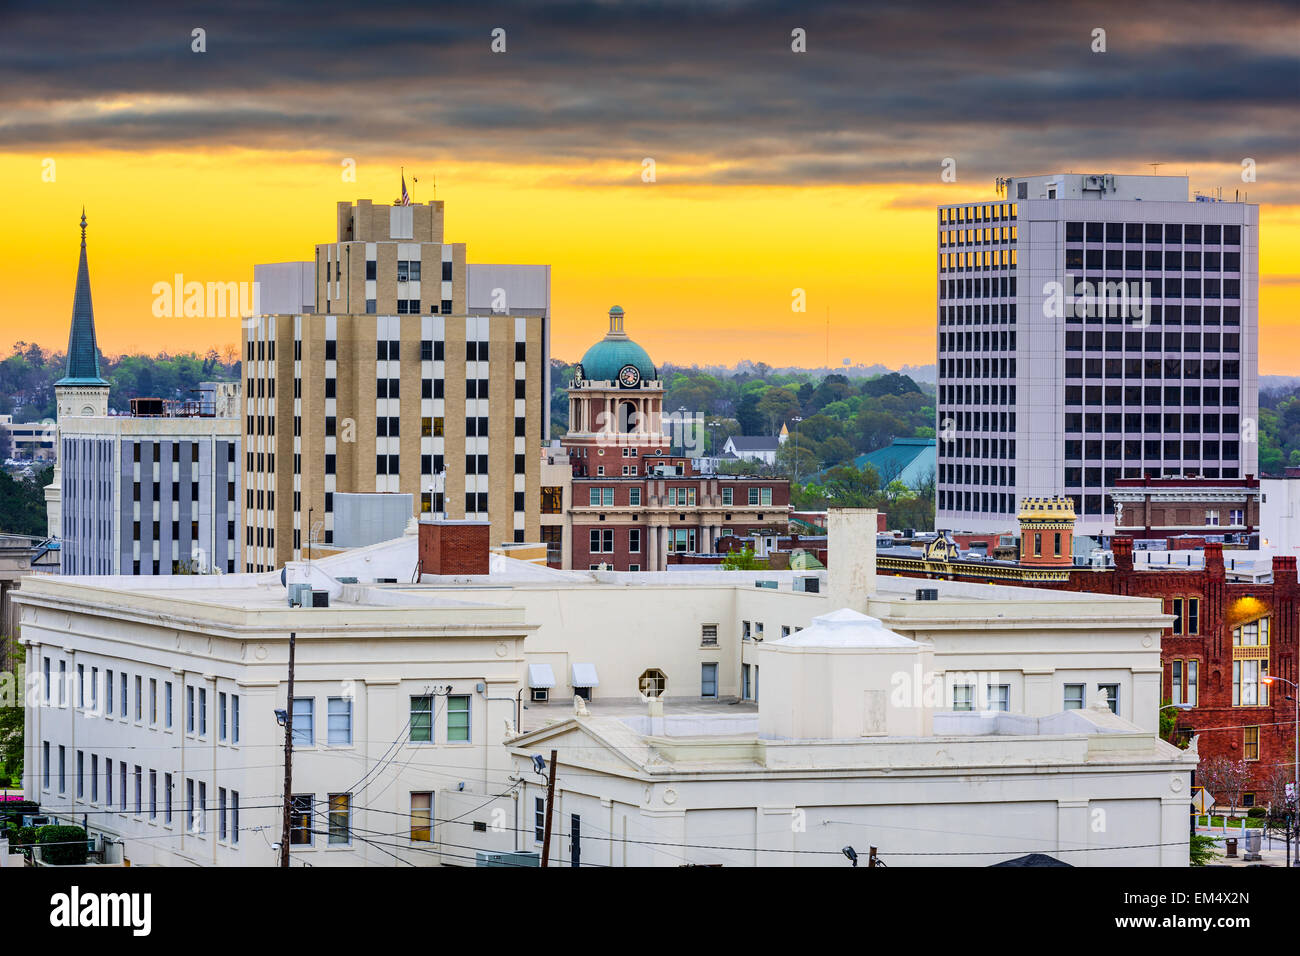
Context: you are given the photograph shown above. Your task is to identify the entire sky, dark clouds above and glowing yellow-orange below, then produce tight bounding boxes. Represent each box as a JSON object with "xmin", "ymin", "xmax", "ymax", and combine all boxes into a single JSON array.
[{"xmin": 0, "ymin": 1, "xmax": 1300, "ymax": 373}]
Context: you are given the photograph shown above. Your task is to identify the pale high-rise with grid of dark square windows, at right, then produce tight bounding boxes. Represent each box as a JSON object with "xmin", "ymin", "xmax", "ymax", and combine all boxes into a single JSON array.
[{"xmin": 936, "ymin": 173, "xmax": 1260, "ymax": 535}]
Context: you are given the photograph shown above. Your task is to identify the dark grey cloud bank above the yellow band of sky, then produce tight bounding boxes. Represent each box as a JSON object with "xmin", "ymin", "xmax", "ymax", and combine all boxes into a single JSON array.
[{"xmin": 0, "ymin": 3, "xmax": 1300, "ymax": 202}]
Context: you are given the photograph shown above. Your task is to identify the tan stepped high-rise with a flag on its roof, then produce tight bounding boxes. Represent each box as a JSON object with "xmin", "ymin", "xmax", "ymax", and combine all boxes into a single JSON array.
[{"xmin": 244, "ymin": 200, "xmax": 550, "ymax": 571}]
